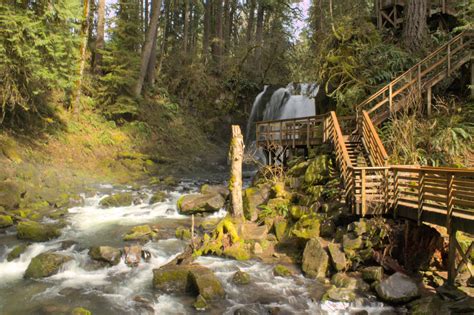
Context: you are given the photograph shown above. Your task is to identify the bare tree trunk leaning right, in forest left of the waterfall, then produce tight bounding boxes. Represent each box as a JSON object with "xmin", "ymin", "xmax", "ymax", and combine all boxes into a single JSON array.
[{"xmin": 133, "ymin": 0, "xmax": 161, "ymax": 96}]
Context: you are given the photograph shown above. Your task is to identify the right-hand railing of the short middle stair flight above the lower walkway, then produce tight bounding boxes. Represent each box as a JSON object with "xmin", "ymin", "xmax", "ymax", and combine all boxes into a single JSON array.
[{"xmin": 358, "ymin": 110, "xmax": 388, "ymax": 166}]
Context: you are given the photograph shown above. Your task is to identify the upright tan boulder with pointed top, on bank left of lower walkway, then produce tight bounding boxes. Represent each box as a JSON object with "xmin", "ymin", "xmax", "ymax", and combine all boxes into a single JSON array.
[{"xmin": 302, "ymin": 237, "xmax": 329, "ymax": 278}]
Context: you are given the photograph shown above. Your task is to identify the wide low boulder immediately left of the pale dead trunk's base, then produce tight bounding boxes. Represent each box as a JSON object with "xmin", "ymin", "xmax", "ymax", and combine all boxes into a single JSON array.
[{"xmin": 177, "ymin": 194, "xmax": 225, "ymax": 214}]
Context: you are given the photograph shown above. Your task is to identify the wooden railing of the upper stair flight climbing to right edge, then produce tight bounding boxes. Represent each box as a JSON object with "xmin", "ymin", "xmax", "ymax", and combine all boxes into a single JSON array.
[{"xmin": 356, "ymin": 31, "xmax": 474, "ymax": 125}]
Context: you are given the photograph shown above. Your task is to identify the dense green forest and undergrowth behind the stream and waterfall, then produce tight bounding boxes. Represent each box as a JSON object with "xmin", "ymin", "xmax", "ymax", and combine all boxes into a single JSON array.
[{"xmin": 0, "ymin": 0, "xmax": 474, "ymax": 184}]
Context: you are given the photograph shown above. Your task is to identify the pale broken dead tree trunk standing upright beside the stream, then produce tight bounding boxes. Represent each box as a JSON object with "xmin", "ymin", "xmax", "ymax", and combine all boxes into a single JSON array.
[{"xmin": 229, "ymin": 125, "xmax": 244, "ymax": 218}]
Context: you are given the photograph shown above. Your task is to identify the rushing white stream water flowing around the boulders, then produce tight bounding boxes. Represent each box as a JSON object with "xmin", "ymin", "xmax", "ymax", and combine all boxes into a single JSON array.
[{"xmin": 0, "ymin": 183, "xmax": 392, "ymax": 314}]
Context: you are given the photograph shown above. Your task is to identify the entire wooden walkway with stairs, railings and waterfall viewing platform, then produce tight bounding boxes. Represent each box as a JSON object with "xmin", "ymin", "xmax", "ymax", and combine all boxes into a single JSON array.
[{"xmin": 256, "ymin": 31, "xmax": 474, "ymax": 283}]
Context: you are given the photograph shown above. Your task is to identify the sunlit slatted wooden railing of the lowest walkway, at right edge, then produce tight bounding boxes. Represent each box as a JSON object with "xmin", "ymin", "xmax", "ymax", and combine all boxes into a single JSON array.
[{"xmin": 352, "ymin": 166, "xmax": 474, "ymax": 229}]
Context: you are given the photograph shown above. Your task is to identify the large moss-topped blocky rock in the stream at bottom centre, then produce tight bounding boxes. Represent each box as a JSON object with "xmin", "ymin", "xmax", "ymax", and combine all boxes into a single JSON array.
[{"xmin": 153, "ymin": 264, "xmax": 225, "ymax": 301}]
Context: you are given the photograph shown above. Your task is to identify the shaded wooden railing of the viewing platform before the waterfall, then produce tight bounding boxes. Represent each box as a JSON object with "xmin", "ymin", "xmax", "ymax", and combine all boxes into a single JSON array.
[{"xmin": 257, "ymin": 115, "xmax": 326, "ymax": 148}]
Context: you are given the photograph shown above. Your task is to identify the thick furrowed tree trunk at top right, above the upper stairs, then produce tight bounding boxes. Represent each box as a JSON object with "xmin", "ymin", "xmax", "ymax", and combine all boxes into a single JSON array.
[{"xmin": 403, "ymin": 0, "xmax": 428, "ymax": 52}]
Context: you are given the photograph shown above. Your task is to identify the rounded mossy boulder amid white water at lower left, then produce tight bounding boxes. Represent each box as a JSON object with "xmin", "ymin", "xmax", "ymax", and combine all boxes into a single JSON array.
[{"xmin": 25, "ymin": 253, "xmax": 72, "ymax": 279}]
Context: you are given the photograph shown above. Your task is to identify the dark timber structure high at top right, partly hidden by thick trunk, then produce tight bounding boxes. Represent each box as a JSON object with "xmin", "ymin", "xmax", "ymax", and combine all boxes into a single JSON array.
[{"xmin": 375, "ymin": 0, "xmax": 457, "ymax": 29}]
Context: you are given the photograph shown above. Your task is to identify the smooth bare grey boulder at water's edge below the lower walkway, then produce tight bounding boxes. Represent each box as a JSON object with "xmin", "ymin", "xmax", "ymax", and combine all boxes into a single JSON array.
[{"xmin": 375, "ymin": 272, "xmax": 420, "ymax": 303}]
